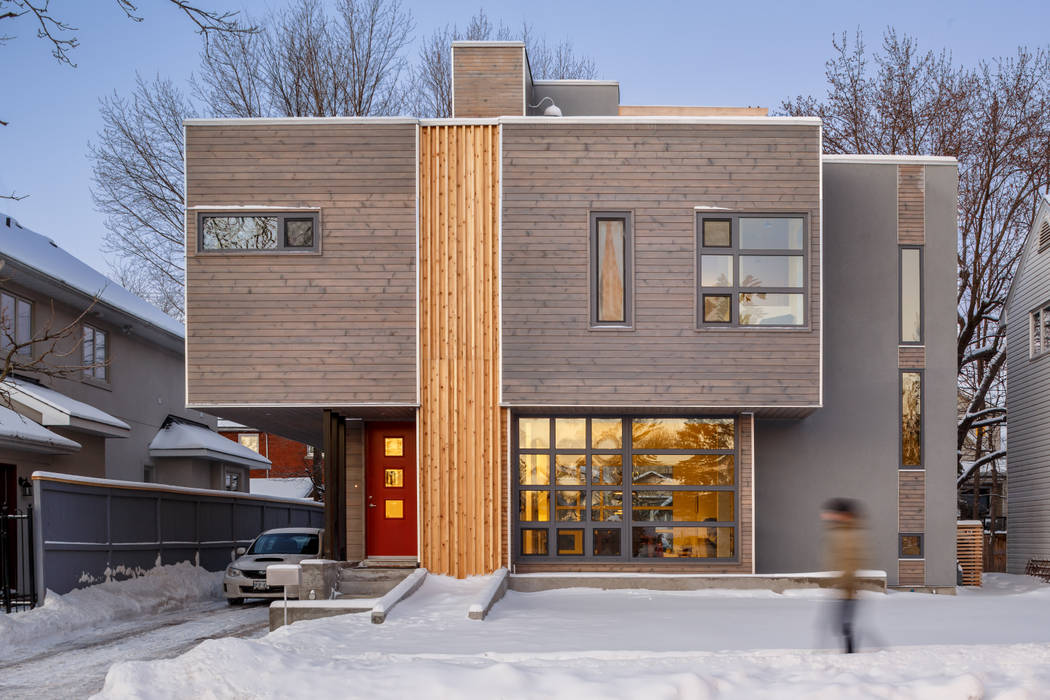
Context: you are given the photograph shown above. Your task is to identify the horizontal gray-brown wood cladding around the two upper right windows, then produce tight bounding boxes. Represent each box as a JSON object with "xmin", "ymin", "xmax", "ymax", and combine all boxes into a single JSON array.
[{"xmin": 502, "ymin": 124, "xmax": 820, "ymax": 408}]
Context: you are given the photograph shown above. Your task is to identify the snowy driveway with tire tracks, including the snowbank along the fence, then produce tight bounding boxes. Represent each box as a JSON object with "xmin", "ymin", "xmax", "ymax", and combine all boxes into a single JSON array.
[{"xmin": 0, "ymin": 564, "xmax": 269, "ymax": 700}]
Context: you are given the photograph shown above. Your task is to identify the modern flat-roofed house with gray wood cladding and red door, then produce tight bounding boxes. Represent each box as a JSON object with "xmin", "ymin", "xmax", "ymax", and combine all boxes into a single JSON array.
[{"xmin": 185, "ymin": 42, "xmax": 957, "ymax": 587}]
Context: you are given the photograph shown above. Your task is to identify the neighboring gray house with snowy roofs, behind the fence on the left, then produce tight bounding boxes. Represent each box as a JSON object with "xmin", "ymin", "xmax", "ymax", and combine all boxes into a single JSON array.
[{"xmin": 0, "ymin": 214, "xmax": 268, "ymax": 508}]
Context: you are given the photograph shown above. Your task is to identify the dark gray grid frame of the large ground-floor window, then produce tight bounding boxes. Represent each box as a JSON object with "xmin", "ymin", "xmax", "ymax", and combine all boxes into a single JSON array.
[{"xmin": 509, "ymin": 411, "xmax": 743, "ymax": 567}]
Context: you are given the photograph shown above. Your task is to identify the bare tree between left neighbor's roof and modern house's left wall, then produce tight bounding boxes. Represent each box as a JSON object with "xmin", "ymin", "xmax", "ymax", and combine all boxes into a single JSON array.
[{"xmin": 88, "ymin": 77, "xmax": 195, "ymax": 317}]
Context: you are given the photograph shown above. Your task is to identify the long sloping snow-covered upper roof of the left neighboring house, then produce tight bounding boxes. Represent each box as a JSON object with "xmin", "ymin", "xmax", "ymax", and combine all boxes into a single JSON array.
[{"xmin": 0, "ymin": 212, "xmax": 184, "ymax": 338}]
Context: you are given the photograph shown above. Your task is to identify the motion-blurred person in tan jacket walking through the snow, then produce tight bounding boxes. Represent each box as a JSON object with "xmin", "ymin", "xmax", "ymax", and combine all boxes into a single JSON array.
[{"xmin": 821, "ymin": 499, "xmax": 866, "ymax": 654}]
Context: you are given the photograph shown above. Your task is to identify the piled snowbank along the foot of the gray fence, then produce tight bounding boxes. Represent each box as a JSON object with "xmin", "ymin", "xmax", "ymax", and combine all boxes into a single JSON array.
[{"xmin": 0, "ymin": 561, "xmax": 223, "ymax": 658}]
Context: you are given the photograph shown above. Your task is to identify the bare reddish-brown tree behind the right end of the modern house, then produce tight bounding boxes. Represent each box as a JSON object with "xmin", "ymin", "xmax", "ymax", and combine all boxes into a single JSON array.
[{"xmin": 782, "ymin": 29, "xmax": 1050, "ymax": 510}]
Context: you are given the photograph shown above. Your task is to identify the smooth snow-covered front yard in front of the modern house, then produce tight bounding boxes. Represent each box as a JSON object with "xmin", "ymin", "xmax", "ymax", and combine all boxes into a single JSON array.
[{"xmin": 102, "ymin": 574, "xmax": 1050, "ymax": 700}]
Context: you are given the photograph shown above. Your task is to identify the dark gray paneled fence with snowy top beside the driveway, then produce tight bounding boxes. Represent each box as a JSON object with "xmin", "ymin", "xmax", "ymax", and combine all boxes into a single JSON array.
[{"xmin": 33, "ymin": 471, "xmax": 324, "ymax": 599}]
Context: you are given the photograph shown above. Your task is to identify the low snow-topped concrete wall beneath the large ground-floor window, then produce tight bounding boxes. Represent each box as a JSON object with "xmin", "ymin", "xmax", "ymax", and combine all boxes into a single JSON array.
[{"xmin": 509, "ymin": 571, "xmax": 886, "ymax": 593}]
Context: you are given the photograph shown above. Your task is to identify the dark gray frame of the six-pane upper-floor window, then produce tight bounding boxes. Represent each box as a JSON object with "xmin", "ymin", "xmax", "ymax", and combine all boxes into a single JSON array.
[{"xmin": 696, "ymin": 213, "xmax": 810, "ymax": 328}]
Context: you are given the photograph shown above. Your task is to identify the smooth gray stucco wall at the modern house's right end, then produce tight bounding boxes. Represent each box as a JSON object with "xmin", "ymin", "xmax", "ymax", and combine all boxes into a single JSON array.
[{"xmin": 755, "ymin": 164, "xmax": 956, "ymax": 586}]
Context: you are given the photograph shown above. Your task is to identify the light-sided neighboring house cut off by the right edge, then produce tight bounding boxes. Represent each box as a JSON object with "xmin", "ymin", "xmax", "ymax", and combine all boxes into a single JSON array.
[{"xmin": 1006, "ymin": 195, "xmax": 1050, "ymax": 574}]
